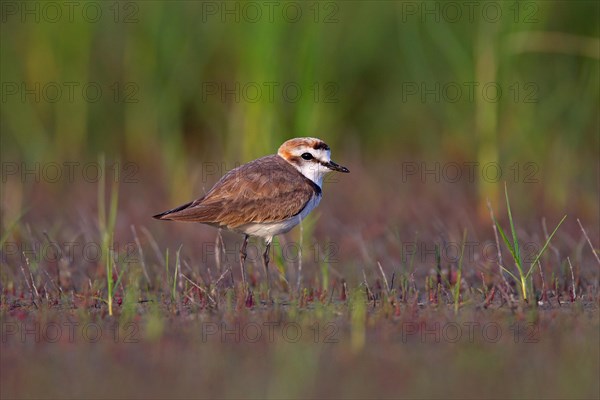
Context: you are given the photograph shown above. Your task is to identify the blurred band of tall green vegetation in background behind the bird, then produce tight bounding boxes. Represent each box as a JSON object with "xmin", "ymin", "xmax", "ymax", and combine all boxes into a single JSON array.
[{"xmin": 0, "ymin": 1, "xmax": 600, "ymax": 214}]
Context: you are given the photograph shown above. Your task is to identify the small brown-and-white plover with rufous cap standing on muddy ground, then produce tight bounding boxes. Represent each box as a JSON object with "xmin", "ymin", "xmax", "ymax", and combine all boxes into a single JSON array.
[{"xmin": 154, "ymin": 138, "xmax": 350, "ymax": 287}]
